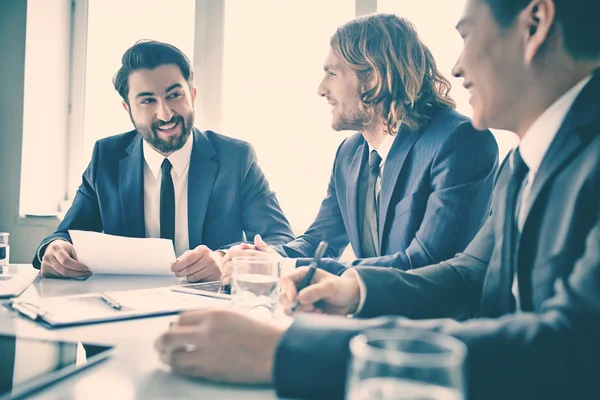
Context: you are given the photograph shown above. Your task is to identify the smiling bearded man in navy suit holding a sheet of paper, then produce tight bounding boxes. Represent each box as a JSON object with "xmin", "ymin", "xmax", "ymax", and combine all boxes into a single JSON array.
[{"xmin": 33, "ymin": 41, "xmax": 293, "ymax": 281}]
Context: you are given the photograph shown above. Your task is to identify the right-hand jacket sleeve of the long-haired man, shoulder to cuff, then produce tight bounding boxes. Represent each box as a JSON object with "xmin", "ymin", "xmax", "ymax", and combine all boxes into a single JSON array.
[{"xmin": 310, "ymin": 123, "xmax": 498, "ymax": 274}]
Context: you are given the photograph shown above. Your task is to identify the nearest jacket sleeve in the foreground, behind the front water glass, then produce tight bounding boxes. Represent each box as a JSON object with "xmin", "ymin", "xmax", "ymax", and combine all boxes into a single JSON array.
[{"xmin": 273, "ymin": 217, "xmax": 600, "ymax": 400}]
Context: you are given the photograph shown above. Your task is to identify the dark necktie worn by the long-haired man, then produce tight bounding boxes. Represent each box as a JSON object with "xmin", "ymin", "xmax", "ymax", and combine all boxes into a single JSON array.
[{"xmin": 362, "ymin": 150, "xmax": 381, "ymax": 257}]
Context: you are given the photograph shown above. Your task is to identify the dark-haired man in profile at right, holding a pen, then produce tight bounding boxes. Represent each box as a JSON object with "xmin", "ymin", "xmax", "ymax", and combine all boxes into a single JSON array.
[{"xmin": 157, "ymin": 0, "xmax": 600, "ymax": 400}]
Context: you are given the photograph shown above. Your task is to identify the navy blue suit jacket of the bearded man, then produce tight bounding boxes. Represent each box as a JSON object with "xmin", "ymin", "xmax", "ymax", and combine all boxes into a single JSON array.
[{"xmin": 33, "ymin": 129, "xmax": 294, "ymax": 268}]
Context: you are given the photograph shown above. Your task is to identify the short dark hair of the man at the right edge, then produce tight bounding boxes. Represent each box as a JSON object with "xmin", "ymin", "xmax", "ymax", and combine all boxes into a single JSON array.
[{"xmin": 479, "ymin": 0, "xmax": 600, "ymax": 59}]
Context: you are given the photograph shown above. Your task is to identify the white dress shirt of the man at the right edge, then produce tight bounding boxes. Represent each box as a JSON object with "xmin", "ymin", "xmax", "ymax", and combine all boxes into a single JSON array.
[{"xmin": 512, "ymin": 75, "xmax": 592, "ymax": 312}]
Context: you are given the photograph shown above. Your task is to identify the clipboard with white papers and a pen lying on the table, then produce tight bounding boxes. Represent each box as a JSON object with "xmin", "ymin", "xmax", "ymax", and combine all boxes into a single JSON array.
[{"xmin": 5, "ymin": 288, "xmax": 229, "ymax": 329}]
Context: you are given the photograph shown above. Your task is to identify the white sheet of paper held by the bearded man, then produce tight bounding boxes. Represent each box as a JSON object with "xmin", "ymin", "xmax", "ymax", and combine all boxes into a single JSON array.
[{"xmin": 69, "ymin": 230, "xmax": 175, "ymax": 275}]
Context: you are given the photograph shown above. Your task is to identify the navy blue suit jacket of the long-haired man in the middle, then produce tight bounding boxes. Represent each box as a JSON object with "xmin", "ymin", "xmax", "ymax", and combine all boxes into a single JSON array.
[{"xmin": 283, "ymin": 107, "xmax": 498, "ymax": 273}]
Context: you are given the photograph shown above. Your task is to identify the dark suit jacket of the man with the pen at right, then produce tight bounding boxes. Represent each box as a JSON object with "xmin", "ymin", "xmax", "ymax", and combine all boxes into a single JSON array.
[{"xmin": 275, "ymin": 71, "xmax": 600, "ymax": 400}]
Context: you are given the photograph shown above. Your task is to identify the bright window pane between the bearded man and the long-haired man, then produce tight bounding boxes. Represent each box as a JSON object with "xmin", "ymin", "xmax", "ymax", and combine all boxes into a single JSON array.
[{"xmin": 222, "ymin": 0, "xmax": 355, "ymax": 234}]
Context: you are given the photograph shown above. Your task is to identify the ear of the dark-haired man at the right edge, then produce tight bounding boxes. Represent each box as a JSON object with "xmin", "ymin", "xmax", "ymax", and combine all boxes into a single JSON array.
[{"xmin": 519, "ymin": 0, "xmax": 556, "ymax": 64}]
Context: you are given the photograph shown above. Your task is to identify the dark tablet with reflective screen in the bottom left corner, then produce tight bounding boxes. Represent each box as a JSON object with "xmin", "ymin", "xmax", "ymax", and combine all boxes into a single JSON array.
[{"xmin": 0, "ymin": 334, "xmax": 112, "ymax": 400}]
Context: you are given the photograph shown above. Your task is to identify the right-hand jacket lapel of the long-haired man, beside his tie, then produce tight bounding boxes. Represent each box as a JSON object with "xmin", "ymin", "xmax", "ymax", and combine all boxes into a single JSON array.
[{"xmin": 379, "ymin": 124, "xmax": 421, "ymax": 248}]
